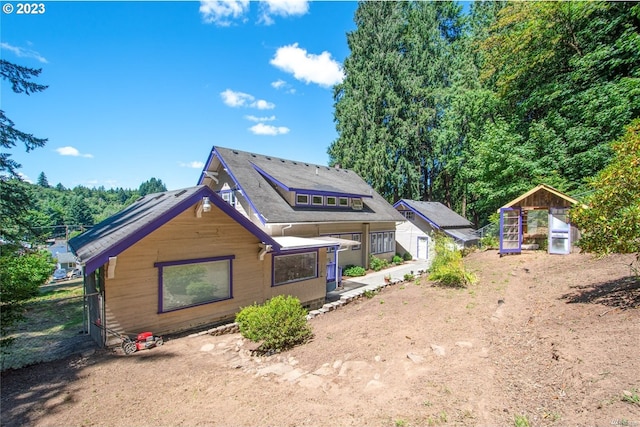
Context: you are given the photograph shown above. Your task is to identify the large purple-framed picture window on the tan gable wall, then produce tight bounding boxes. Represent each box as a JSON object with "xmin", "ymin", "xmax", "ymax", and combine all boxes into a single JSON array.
[{"xmin": 155, "ymin": 256, "xmax": 234, "ymax": 313}]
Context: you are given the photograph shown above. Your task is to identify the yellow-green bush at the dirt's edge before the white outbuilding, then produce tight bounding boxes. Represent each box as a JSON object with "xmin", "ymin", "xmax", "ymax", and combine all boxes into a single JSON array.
[{"xmin": 429, "ymin": 235, "xmax": 475, "ymax": 287}]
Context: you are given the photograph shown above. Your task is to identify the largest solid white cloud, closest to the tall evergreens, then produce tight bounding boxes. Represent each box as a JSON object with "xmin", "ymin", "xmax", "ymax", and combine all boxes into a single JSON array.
[{"xmin": 270, "ymin": 43, "xmax": 344, "ymax": 87}]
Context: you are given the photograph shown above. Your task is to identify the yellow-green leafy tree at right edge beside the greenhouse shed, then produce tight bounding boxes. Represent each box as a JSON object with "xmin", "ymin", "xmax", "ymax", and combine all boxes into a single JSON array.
[{"xmin": 570, "ymin": 119, "xmax": 640, "ymax": 254}]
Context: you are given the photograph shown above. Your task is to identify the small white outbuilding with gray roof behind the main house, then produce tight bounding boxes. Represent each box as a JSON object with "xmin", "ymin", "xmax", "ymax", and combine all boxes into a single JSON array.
[{"xmin": 393, "ymin": 199, "xmax": 478, "ymax": 260}]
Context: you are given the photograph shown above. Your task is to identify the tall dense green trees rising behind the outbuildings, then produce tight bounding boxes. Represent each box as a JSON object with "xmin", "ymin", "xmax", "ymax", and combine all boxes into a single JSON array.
[{"xmin": 328, "ymin": 1, "xmax": 640, "ymax": 226}]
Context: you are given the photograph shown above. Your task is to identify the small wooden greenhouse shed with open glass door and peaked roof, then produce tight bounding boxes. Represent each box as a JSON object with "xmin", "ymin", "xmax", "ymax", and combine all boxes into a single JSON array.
[{"xmin": 498, "ymin": 184, "xmax": 579, "ymax": 256}]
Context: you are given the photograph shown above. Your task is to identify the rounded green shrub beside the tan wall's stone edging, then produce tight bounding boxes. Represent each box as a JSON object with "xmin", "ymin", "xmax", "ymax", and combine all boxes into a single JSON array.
[{"xmin": 236, "ymin": 295, "xmax": 313, "ymax": 353}]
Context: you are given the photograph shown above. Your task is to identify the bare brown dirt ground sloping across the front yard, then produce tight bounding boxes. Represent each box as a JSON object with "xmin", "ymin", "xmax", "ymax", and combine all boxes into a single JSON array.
[{"xmin": 0, "ymin": 251, "xmax": 640, "ymax": 427}]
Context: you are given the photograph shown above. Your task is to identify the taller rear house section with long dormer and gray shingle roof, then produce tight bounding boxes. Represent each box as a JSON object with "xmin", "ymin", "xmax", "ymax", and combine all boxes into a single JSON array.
[{"xmin": 199, "ymin": 146, "xmax": 405, "ymax": 290}]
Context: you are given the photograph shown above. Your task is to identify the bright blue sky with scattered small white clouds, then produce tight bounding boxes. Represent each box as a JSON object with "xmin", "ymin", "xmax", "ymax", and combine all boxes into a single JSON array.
[{"xmin": 0, "ymin": 0, "xmax": 357, "ymax": 190}]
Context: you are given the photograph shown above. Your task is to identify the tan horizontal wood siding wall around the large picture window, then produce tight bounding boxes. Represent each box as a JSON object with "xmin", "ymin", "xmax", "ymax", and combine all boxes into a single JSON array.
[{"xmin": 105, "ymin": 206, "xmax": 326, "ymax": 334}]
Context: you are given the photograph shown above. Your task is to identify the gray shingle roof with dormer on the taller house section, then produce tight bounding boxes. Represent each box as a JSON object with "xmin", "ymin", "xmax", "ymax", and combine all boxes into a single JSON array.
[{"xmin": 208, "ymin": 147, "xmax": 405, "ymax": 223}]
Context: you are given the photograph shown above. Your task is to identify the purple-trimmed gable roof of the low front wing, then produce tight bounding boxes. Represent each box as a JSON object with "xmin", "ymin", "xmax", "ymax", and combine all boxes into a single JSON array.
[{"xmin": 69, "ymin": 185, "xmax": 280, "ymax": 274}]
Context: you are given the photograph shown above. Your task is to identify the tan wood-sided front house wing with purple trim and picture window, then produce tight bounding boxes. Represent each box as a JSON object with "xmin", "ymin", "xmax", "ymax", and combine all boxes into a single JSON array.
[{"xmin": 69, "ymin": 185, "xmax": 336, "ymax": 345}]
